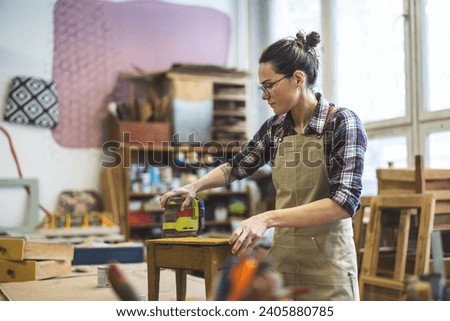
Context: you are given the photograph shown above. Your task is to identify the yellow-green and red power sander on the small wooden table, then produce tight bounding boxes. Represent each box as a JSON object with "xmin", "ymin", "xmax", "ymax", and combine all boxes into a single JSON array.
[{"xmin": 162, "ymin": 196, "xmax": 205, "ymax": 237}]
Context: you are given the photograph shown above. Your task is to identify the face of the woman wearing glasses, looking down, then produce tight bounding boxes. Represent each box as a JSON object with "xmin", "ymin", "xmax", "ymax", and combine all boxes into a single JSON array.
[{"xmin": 258, "ymin": 62, "xmax": 299, "ymax": 115}]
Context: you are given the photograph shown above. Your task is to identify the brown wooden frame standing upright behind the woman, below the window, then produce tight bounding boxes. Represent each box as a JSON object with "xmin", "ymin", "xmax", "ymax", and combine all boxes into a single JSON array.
[{"xmin": 359, "ymin": 193, "xmax": 436, "ymax": 300}]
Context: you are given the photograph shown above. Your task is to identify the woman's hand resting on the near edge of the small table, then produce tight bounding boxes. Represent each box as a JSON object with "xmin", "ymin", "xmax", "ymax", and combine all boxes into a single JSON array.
[{"xmin": 230, "ymin": 214, "xmax": 267, "ymax": 257}]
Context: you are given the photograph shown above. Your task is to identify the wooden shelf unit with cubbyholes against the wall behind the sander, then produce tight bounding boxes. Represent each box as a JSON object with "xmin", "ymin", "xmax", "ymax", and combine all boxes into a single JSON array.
[{"xmin": 112, "ymin": 70, "xmax": 252, "ymax": 239}]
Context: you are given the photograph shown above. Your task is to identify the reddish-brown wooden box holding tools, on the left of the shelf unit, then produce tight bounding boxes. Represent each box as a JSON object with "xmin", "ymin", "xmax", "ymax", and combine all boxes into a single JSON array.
[{"xmin": 111, "ymin": 117, "xmax": 171, "ymax": 147}]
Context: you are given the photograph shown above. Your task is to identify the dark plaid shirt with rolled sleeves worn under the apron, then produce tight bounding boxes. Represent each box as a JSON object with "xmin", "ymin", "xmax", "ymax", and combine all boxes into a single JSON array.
[{"xmin": 229, "ymin": 94, "xmax": 367, "ymax": 216}]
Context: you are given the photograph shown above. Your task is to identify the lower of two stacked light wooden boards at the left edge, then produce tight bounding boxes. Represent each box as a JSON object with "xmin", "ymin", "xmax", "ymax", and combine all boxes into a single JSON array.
[{"xmin": 0, "ymin": 260, "xmax": 71, "ymax": 282}]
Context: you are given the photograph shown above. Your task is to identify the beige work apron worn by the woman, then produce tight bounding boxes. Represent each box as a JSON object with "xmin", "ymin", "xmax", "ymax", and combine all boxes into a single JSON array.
[{"xmin": 269, "ymin": 123, "xmax": 359, "ymax": 301}]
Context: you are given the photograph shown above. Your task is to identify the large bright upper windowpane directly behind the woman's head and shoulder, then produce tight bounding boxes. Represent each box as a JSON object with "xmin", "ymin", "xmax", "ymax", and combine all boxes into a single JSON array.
[{"xmin": 334, "ymin": 0, "xmax": 406, "ymax": 122}]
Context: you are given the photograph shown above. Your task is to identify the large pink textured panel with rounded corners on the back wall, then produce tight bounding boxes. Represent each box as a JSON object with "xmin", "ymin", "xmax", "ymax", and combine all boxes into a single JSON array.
[{"xmin": 52, "ymin": 0, "xmax": 230, "ymax": 148}]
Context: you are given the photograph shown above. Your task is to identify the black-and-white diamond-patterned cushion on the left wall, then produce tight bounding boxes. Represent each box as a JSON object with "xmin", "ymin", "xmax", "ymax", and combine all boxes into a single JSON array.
[{"xmin": 4, "ymin": 77, "xmax": 58, "ymax": 128}]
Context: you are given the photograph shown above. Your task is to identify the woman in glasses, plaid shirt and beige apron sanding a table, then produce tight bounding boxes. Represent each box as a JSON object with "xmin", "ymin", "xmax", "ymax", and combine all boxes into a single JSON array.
[{"xmin": 161, "ymin": 32, "xmax": 367, "ymax": 301}]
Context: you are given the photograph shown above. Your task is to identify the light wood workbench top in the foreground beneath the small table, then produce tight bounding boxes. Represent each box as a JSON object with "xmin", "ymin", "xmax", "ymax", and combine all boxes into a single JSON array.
[{"xmin": 0, "ymin": 262, "xmax": 206, "ymax": 301}]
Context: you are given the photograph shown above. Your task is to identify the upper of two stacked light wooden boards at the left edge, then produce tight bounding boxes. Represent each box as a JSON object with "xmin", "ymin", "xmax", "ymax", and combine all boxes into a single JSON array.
[{"xmin": 0, "ymin": 238, "xmax": 74, "ymax": 261}]
